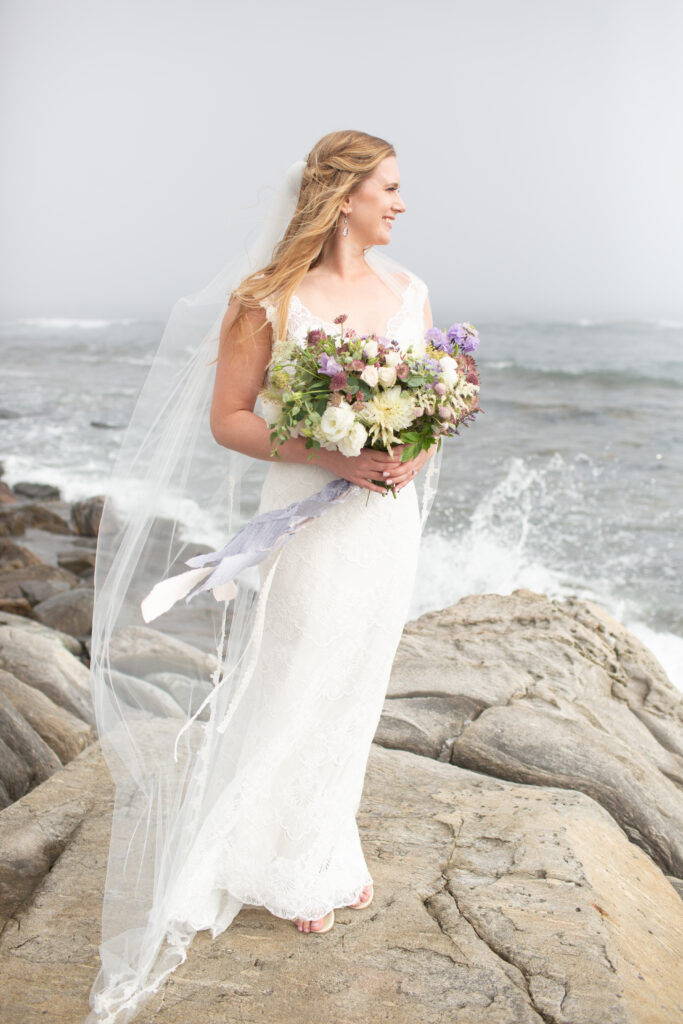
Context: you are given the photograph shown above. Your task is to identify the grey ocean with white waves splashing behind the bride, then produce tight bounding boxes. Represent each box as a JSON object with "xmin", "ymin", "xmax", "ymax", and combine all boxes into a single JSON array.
[{"xmin": 0, "ymin": 318, "xmax": 683, "ymax": 690}]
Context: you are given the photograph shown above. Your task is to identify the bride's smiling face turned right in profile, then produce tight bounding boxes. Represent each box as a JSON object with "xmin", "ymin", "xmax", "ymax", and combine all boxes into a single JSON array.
[{"xmin": 342, "ymin": 157, "xmax": 405, "ymax": 246}]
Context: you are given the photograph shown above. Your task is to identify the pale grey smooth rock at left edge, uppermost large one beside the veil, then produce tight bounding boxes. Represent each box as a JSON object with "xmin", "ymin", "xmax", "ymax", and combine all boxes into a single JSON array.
[{"xmin": 0, "ymin": 626, "xmax": 95, "ymax": 728}]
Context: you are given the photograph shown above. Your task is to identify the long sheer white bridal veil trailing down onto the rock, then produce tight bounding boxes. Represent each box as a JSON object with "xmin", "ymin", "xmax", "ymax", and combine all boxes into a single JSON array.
[{"xmin": 87, "ymin": 155, "xmax": 440, "ymax": 1024}]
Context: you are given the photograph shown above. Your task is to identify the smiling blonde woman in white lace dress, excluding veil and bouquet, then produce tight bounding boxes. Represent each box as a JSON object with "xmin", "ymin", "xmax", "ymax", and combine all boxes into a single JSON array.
[{"xmin": 205, "ymin": 132, "xmax": 431, "ymax": 932}]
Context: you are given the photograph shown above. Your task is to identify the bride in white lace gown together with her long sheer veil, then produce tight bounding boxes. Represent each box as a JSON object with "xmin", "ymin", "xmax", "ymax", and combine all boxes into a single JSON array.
[{"xmin": 88, "ymin": 131, "xmax": 438, "ymax": 1024}]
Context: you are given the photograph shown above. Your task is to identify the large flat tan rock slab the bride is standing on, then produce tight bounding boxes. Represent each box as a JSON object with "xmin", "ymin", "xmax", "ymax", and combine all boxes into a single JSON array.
[{"xmin": 0, "ymin": 743, "xmax": 683, "ymax": 1024}]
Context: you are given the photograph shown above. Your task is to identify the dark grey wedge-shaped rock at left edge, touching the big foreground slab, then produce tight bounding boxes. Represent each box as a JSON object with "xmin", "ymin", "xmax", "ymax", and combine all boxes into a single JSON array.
[{"xmin": 0, "ymin": 693, "xmax": 61, "ymax": 806}]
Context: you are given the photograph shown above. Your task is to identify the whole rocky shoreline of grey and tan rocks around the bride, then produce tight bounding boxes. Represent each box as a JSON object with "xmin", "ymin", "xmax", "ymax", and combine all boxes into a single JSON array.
[{"xmin": 0, "ymin": 472, "xmax": 683, "ymax": 1024}]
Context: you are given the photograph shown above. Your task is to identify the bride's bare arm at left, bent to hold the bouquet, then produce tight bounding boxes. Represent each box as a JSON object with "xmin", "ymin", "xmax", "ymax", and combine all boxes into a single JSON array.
[{"xmin": 210, "ymin": 300, "xmax": 413, "ymax": 494}]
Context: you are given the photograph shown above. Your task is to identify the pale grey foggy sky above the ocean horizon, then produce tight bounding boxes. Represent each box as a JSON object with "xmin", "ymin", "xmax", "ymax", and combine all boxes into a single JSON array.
[{"xmin": 0, "ymin": 0, "xmax": 683, "ymax": 323}]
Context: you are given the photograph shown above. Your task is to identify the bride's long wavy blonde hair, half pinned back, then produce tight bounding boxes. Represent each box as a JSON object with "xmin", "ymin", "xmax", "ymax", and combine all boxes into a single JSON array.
[{"xmin": 230, "ymin": 131, "xmax": 396, "ymax": 348}]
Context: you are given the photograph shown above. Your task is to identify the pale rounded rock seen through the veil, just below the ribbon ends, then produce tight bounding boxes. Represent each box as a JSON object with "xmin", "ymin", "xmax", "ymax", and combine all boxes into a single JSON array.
[{"xmin": 110, "ymin": 626, "xmax": 216, "ymax": 678}]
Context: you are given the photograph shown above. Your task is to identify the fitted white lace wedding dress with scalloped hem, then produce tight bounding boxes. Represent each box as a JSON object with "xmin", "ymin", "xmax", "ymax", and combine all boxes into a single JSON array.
[{"xmin": 163, "ymin": 275, "xmax": 426, "ymax": 936}]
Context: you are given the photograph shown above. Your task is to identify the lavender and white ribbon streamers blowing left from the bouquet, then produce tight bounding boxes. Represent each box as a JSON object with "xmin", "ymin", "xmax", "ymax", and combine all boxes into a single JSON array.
[{"xmin": 140, "ymin": 477, "xmax": 356, "ymax": 623}]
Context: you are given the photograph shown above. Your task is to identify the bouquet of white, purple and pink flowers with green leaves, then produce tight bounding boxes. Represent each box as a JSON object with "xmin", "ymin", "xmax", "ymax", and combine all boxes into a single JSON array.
[{"xmin": 260, "ymin": 314, "xmax": 480, "ymax": 462}]
